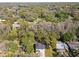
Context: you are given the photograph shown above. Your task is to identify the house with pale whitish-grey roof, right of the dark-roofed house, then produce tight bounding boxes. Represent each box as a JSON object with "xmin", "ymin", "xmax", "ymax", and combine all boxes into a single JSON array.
[{"xmin": 56, "ymin": 41, "xmax": 68, "ymax": 54}]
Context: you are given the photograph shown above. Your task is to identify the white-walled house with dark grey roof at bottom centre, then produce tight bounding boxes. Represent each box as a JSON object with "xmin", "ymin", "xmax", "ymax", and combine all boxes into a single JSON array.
[{"xmin": 35, "ymin": 42, "xmax": 45, "ymax": 57}]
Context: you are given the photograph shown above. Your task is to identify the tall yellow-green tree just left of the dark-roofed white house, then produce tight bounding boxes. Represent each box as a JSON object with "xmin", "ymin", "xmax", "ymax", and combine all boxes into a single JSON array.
[{"xmin": 21, "ymin": 32, "xmax": 35, "ymax": 54}]
